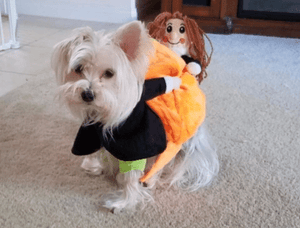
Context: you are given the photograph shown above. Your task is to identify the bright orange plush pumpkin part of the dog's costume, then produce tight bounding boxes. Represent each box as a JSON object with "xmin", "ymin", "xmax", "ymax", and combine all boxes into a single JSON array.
[{"xmin": 140, "ymin": 40, "xmax": 206, "ymax": 182}]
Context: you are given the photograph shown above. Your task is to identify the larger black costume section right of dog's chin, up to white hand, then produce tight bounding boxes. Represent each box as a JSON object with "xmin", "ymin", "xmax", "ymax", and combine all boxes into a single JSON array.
[{"xmin": 98, "ymin": 78, "xmax": 167, "ymax": 161}]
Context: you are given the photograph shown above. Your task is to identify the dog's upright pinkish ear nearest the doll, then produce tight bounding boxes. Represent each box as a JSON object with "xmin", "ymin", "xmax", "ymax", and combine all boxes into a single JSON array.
[{"xmin": 114, "ymin": 21, "xmax": 146, "ymax": 61}]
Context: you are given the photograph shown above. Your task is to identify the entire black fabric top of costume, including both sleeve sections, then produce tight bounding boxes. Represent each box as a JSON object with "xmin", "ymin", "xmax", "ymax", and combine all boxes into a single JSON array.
[{"xmin": 72, "ymin": 78, "xmax": 167, "ymax": 161}]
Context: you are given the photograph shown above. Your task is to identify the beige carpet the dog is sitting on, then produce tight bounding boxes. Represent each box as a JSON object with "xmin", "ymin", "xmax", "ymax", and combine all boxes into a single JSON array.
[{"xmin": 0, "ymin": 35, "xmax": 300, "ymax": 228}]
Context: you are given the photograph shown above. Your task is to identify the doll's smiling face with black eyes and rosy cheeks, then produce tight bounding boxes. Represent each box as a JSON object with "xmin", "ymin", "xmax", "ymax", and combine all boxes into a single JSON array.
[{"xmin": 162, "ymin": 19, "xmax": 188, "ymax": 56}]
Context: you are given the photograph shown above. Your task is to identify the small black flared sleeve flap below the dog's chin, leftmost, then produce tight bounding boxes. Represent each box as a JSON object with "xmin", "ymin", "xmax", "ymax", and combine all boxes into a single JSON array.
[{"xmin": 72, "ymin": 124, "xmax": 102, "ymax": 156}]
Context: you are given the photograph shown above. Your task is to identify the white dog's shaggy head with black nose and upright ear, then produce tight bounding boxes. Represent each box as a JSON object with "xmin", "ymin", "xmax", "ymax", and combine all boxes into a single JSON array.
[{"xmin": 52, "ymin": 22, "xmax": 153, "ymax": 131}]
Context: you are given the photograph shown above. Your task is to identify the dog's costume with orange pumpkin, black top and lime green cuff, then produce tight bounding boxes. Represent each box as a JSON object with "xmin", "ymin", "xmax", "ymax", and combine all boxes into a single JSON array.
[{"xmin": 72, "ymin": 40, "xmax": 205, "ymax": 182}]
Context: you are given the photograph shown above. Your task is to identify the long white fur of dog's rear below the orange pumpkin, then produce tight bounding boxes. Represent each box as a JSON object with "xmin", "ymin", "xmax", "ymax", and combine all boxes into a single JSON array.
[{"xmin": 170, "ymin": 124, "xmax": 219, "ymax": 191}]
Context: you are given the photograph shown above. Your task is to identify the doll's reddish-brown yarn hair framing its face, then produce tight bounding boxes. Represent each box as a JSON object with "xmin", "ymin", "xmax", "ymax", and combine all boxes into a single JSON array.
[{"xmin": 147, "ymin": 12, "xmax": 213, "ymax": 83}]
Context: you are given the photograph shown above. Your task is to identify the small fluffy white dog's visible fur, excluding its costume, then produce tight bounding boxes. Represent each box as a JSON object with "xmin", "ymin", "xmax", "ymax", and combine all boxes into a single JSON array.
[{"xmin": 52, "ymin": 22, "xmax": 219, "ymax": 210}]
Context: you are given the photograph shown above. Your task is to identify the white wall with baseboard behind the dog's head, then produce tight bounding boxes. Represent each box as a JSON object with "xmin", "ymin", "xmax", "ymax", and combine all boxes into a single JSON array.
[{"xmin": 14, "ymin": 0, "xmax": 137, "ymax": 23}]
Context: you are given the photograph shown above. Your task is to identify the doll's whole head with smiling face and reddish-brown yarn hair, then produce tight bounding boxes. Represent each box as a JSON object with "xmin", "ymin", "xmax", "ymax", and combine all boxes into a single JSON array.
[{"xmin": 148, "ymin": 12, "xmax": 211, "ymax": 83}]
